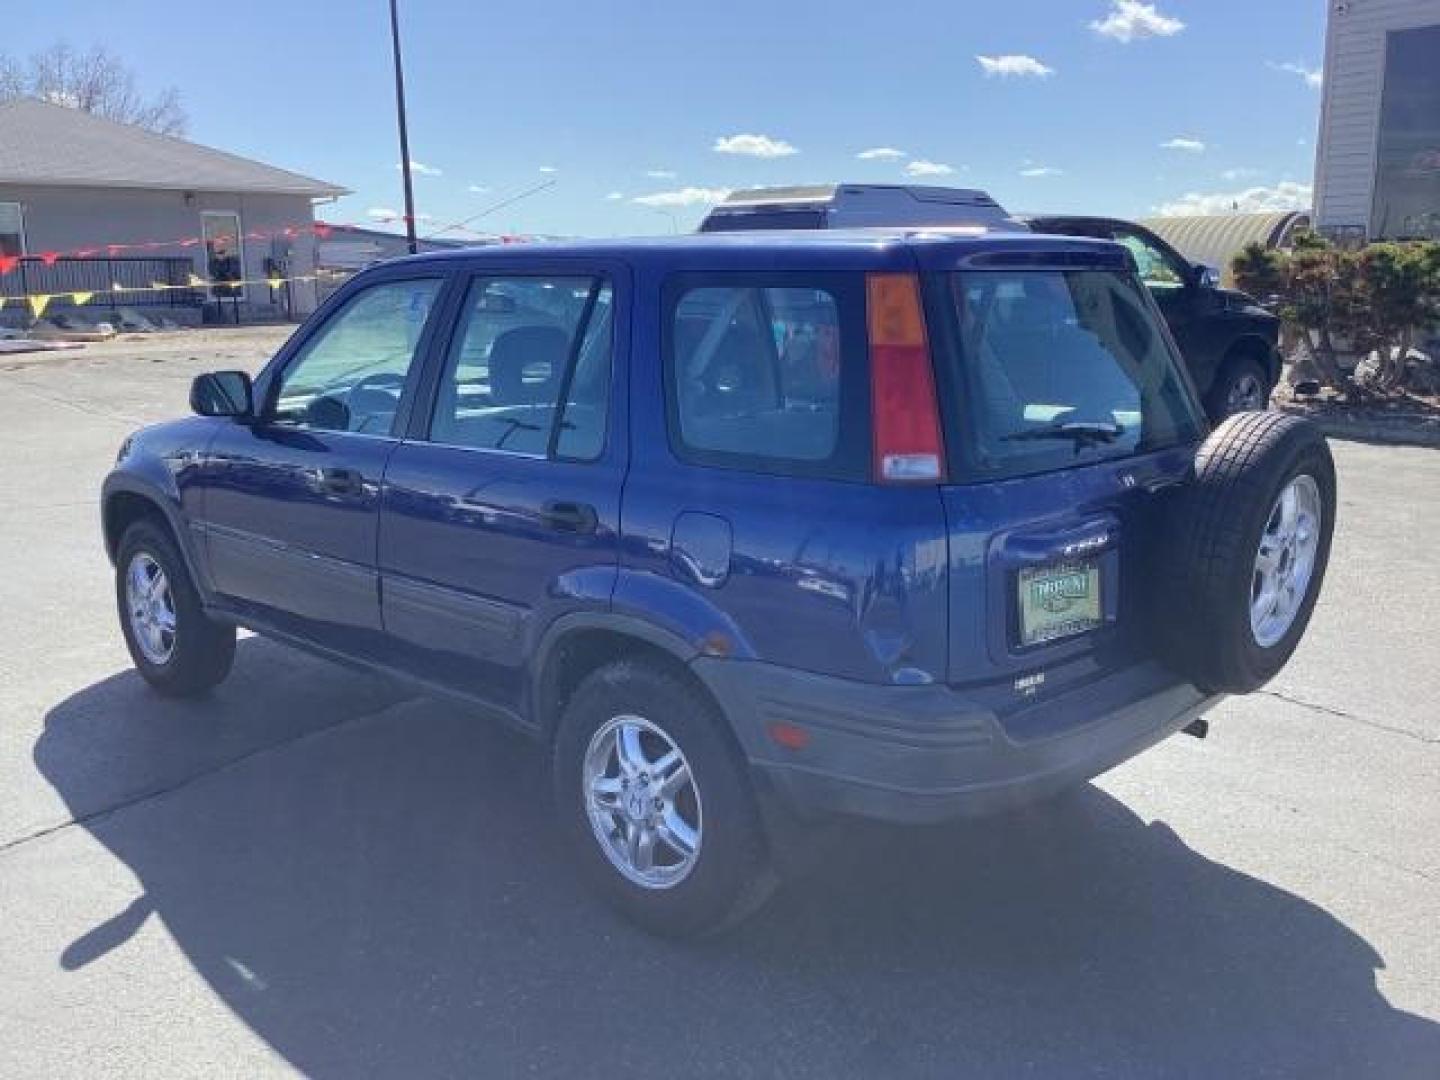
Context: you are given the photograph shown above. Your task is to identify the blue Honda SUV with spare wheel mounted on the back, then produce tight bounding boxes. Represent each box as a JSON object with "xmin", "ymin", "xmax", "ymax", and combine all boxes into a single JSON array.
[{"xmin": 102, "ymin": 230, "xmax": 1335, "ymax": 933}]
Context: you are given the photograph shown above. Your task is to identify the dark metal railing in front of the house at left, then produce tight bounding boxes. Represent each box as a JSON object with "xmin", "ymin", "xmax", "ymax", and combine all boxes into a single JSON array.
[{"xmin": 0, "ymin": 255, "xmax": 206, "ymax": 308}]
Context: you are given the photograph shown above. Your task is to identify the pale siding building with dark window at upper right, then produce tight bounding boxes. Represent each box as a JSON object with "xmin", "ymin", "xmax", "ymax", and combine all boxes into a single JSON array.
[{"xmin": 1315, "ymin": 0, "xmax": 1440, "ymax": 240}]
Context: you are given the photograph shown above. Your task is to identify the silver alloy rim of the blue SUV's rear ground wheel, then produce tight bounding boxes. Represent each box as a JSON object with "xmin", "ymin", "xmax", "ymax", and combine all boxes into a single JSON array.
[{"xmin": 580, "ymin": 716, "xmax": 701, "ymax": 888}]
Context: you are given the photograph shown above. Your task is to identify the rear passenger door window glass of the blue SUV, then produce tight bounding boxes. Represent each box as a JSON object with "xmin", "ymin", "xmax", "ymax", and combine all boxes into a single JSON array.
[{"xmin": 431, "ymin": 276, "xmax": 615, "ymax": 461}]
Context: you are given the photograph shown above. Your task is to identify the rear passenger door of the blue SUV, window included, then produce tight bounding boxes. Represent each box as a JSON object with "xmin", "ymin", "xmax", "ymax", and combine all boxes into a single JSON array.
[{"xmin": 379, "ymin": 266, "xmax": 626, "ymax": 714}]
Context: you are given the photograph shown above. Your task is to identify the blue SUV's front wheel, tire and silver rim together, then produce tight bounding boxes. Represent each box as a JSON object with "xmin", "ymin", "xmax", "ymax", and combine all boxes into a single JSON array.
[{"xmin": 115, "ymin": 518, "xmax": 235, "ymax": 697}]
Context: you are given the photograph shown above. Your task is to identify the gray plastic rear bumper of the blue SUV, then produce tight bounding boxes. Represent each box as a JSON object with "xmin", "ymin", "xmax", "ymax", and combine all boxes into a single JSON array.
[{"xmin": 694, "ymin": 658, "xmax": 1220, "ymax": 824}]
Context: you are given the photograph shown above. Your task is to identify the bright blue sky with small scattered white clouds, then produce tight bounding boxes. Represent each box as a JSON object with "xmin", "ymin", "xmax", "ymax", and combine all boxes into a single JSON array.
[{"xmin": 8, "ymin": 0, "xmax": 1325, "ymax": 235}]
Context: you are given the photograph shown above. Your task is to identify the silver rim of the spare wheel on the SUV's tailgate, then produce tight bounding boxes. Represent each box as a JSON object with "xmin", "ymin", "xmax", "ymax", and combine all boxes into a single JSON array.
[{"xmin": 1250, "ymin": 474, "xmax": 1323, "ymax": 648}]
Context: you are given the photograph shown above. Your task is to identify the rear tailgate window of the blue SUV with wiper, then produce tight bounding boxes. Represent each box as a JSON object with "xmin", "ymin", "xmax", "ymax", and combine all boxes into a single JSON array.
[{"xmin": 940, "ymin": 269, "xmax": 1202, "ymax": 478}]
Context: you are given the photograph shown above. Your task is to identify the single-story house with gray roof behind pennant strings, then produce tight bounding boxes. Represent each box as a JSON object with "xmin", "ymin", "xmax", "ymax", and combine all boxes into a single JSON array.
[{"xmin": 0, "ymin": 98, "xmax": 348, "ymax": 317}]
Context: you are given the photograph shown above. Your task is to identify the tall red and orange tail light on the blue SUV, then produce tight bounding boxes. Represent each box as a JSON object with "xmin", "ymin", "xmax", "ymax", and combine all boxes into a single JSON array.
[{"xmin": 865, "ymin": 274, "xmax": 945, "ymax": 484}]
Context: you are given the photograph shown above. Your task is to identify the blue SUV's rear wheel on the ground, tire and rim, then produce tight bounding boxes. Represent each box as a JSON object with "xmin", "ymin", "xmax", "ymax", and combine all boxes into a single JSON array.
[{"xmin": 553, "ymin": 660, "xmax": 773, "ymax": 937}]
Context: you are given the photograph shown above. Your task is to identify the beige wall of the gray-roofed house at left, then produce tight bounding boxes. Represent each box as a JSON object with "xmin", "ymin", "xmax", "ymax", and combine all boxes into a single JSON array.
[{"xmin": 0, "ymin": 184, "xmax": 324, "ymax": 315}]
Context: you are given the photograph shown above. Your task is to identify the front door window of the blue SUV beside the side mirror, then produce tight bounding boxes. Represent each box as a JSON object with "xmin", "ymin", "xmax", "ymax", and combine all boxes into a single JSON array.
[{"xmin": 271, "ymin": 278, "xmax": 441, "ymax": 435}]
